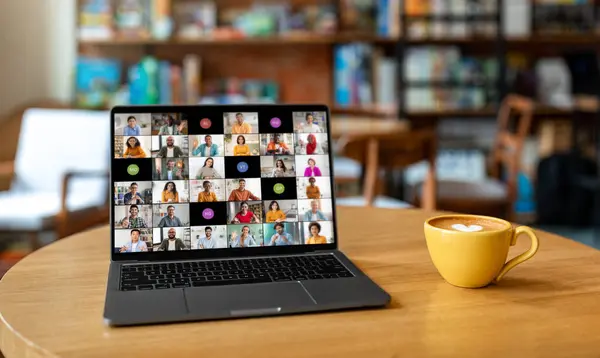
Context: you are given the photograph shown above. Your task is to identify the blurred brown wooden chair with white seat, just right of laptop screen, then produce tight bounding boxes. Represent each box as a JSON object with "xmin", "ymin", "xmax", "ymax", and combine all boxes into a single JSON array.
[{"xmin": 334, "ymin": 129, "xmax": 436, "ymax": 210}]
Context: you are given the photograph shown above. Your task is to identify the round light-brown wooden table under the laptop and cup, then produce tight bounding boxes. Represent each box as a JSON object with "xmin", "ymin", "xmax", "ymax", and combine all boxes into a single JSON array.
[{"xmin": 0, "ymin": 208, "xmax": 600, "ymax": 358}]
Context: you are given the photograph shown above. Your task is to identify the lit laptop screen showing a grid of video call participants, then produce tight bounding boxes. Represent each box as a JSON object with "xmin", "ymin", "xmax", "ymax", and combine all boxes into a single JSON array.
[{"xmin": 111, "ymin": 106, "xmax": 335, "ymax": 257}]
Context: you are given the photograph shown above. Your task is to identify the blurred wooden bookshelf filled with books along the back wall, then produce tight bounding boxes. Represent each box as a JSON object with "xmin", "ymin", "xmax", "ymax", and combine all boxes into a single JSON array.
[{"xmin": 75, "ymin": 0, "xmax": 600, "ymax": 120}]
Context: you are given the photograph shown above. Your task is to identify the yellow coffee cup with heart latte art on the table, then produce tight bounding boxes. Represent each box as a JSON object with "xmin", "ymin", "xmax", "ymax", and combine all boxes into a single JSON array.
[{"xmin": 425, "ymin": 214, "xmax": 539, "ymax": 288}]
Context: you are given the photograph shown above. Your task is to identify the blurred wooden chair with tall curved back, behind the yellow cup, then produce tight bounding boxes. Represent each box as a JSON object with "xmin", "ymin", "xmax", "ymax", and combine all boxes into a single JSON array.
[{"xmin": 416, "ymin": 95, "xmax": 535, "ymax": 220}]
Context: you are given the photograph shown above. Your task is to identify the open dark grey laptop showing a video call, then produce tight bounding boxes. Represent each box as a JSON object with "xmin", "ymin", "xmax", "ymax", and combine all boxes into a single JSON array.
[{"xmin": 104, "ymin": 105, "xmax": 390, "ymax": 326}]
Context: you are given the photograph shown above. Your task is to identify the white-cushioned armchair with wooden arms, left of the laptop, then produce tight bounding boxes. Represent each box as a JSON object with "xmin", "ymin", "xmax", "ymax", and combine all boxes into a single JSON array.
[{"xmin": 0, "ymin": 103, "xmax": 110, "ymax": 249}]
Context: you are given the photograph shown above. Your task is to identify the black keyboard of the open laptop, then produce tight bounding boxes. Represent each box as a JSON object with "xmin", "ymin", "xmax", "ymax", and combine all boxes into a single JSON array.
[{"xmin": 119, "ymin": 255, "xmax": 354, "ymax": 291}]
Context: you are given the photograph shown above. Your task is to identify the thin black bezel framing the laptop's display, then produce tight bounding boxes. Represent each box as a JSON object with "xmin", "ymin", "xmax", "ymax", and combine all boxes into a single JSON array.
[{"xmin": 109, "ymin": 104, "xmax": 339, "ymax": 262}]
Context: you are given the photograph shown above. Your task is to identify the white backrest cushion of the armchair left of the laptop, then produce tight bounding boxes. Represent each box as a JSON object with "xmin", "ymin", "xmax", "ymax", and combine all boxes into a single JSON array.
[{"xmin": 13, "ymin": 108, "xmax": 110, "ymax": 193}]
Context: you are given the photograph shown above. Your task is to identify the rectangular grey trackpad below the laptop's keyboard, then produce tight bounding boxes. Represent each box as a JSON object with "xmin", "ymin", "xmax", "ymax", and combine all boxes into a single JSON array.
[{"xmin": 185, "ymin": 281, "xmax": 316, "ymax": 316}]
